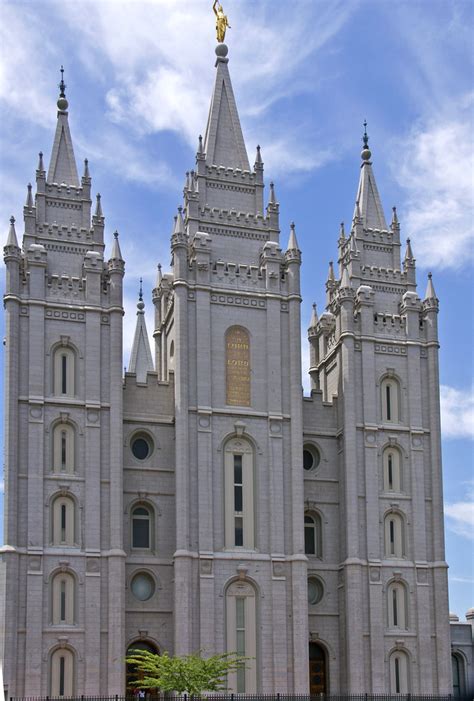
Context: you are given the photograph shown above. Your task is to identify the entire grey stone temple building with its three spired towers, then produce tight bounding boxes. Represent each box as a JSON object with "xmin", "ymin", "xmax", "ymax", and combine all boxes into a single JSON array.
[{"xmin": 0, "ymin": 45, "xmax": 451, "ymax": 696}]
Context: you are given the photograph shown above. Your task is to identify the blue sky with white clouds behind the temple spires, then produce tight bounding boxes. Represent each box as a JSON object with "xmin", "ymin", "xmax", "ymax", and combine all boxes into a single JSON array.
[{"xmin": 0, "ymin": 0, "xmax": 474, "ymax": 618}]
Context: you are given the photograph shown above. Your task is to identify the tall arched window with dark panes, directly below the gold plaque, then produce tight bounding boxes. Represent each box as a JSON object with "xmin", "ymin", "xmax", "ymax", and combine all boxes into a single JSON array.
[{"xmin": 224, "ymin": 438, "xmax": 255, "ymax": 550}]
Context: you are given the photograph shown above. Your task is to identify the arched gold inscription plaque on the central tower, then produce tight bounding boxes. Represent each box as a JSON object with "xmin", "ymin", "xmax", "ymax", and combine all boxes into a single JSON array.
[{"xmin": 225, "ymin": 326, "xmax": 250, "ymax": 406}]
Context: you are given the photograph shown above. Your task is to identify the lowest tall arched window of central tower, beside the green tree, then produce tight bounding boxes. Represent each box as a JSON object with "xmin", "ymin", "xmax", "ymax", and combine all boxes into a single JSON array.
[{"xmin": 226, "ymin": 581, "xmax": 257, "ymax": 694}]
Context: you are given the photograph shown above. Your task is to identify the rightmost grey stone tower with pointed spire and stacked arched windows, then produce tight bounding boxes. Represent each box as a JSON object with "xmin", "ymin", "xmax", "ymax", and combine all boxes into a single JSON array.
[{"xmin": 305, "ymin": 132, "xmax": 450, "ymax": 693}]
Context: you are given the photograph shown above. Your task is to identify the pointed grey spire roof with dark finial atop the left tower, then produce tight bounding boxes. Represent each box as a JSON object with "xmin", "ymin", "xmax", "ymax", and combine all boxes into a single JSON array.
[{"xmin": 47, "ymin": 66, "xmax": 79, "ymax": 187}]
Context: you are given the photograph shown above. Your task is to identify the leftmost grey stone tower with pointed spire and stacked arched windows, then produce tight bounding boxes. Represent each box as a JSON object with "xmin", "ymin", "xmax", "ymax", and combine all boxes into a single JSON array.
[{"xmin": 2, "ymin": 71, "xmax": 124, "ymax": 696}]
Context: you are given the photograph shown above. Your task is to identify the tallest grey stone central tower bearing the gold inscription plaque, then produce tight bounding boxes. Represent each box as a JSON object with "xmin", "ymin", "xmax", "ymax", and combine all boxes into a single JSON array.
[{"xmin": 154, "ymin": 44, "xmax": 308, "ymax": 693}]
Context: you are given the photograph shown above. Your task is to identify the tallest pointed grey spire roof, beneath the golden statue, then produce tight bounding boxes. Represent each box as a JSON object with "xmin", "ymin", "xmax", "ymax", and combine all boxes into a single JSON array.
[{"xmin": 204, "ymin": 44, "xmax": 250, "ymax": 170}]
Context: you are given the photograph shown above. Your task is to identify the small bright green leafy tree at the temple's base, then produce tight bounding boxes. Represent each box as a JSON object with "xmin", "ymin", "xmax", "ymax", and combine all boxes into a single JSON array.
[{"xmin": 126, "ymin": 650, "xmax": 248, "ymax": 696}]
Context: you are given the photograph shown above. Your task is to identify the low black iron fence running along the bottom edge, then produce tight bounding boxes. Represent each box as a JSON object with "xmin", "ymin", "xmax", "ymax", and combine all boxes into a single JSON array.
[{"xmin": 10, "ymin": 693, "xmax": 474, "ymax": 701}]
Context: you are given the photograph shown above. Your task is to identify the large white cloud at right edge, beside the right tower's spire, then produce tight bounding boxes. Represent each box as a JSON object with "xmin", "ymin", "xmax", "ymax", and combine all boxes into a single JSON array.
[{"xmin": 396, "ymin": 94, "xmax": 474, "ymax": 268}]
